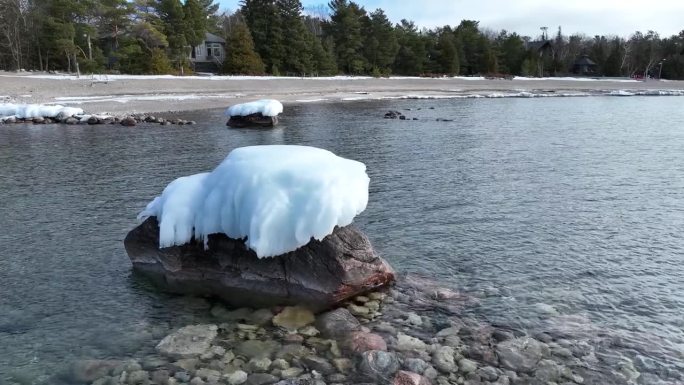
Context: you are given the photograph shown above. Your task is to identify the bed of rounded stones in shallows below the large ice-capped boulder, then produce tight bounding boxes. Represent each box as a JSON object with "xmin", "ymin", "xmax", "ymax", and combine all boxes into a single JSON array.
[{"xmin": 62, "ymin": 274, "xmax": 624, "ymax": 385}]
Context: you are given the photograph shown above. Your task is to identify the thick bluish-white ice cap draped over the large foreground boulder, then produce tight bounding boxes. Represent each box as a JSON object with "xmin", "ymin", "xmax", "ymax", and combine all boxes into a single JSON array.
[{"xmin": 138, "ymin": 145, "xmax": 370, "ymax": 258}]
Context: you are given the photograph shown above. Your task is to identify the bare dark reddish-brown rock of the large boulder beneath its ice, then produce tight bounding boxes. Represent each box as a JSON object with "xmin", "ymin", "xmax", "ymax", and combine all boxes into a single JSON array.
[{"xmin": 124, "ymin": 217, "xmax": 394, "ymax": 311}]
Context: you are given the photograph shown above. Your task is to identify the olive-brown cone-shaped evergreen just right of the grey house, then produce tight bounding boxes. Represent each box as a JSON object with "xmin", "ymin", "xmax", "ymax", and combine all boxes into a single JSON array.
[{"xmin": 223, "ymin": 23, "xmax": 264, "ymax": 75}]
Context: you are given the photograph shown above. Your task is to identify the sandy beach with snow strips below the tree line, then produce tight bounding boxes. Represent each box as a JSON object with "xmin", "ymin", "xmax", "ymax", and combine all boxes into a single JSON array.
[{"xmin": 0, "ymin": 71, "xmax": 684, "ymax": 114}]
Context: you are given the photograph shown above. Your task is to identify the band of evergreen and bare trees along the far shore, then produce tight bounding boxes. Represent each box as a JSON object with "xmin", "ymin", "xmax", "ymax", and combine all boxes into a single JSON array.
[{"xmin": 0, "ymin": 0, "xmax": 684, "ymax": 79}]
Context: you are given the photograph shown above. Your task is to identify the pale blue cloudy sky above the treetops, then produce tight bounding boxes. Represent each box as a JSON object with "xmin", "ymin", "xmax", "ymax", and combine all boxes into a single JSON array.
[{"xmin": 217, "ymin": 0, "xmax": 684, "ymax": 37}]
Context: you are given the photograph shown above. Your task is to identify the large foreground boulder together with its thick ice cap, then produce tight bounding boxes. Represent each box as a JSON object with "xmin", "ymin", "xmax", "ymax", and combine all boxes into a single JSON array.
[{"xmin": 124, "ymin": 146, "xmax": 394, "ymax": 310}]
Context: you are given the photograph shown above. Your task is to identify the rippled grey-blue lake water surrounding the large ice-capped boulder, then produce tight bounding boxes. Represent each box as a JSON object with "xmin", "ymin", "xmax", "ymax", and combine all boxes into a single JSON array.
[{"xmin": 0, "ymin": 97, "xmax": 684, "ymax": 384}]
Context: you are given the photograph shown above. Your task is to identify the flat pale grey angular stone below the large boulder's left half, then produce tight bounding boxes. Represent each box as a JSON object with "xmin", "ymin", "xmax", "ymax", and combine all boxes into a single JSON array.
[{"xmin": 156, "ymin": 325, "xmax": 218, "ymax": 358}]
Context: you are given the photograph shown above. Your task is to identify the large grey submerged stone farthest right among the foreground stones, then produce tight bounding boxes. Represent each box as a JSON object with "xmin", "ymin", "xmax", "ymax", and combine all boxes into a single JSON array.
[{"xmin": 496, "ymin": 337, "xmax": 548, "ymax": 373}]
